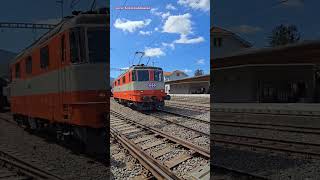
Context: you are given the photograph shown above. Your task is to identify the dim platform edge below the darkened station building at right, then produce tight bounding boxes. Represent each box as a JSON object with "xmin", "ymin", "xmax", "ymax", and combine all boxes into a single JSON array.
[{"xmin": 211, "ymin": 103, "xmax": 320, "ymax": 116}]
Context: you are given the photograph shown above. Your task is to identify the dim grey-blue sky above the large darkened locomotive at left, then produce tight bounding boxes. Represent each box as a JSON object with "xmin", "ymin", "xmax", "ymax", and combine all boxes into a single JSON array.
[{"xmin": 0, "ymin": 0, "xmax": 107, "ymax": 53}]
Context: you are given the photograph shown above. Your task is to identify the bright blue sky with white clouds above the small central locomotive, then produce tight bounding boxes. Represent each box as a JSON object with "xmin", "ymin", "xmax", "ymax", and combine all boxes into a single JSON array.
[{"xmin": 110, "ymin": 0, "xmax": 210, "ymax": 77}]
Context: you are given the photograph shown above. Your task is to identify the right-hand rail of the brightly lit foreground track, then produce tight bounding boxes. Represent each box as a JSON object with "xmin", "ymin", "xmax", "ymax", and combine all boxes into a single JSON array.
[{"xmin": 110, "ymin": 110, "xmax": 210, "ymax": 158}]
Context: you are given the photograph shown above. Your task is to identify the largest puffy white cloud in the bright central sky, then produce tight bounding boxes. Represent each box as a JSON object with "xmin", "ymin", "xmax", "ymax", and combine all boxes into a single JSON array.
[{"xmin": 163, "ymin": 13, "xmax": 192, "ymax": 35}]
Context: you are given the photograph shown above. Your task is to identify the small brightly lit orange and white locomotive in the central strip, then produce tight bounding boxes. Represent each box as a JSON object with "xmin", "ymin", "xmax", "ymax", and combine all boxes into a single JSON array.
[{"xmin": 112, "ymin": 64, "xmax": 170, "ymax": 110}]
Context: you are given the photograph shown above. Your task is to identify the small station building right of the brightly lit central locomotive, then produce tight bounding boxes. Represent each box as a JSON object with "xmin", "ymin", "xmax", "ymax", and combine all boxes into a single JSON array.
[{"xmin": 165, "ymin": 75, "xmax": 210, "ymax": 94}]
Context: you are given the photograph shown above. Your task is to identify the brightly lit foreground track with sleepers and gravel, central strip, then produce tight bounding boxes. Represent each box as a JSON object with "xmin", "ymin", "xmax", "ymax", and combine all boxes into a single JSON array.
[{"xmin": 110, "ymin": 110, "xmax": 210, "ymax": 179}]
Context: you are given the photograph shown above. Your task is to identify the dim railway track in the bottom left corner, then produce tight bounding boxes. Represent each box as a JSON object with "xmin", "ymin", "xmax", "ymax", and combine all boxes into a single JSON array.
[{"xmin": 0, "ymin": 151, "xmax": 62, "ymax": 180}]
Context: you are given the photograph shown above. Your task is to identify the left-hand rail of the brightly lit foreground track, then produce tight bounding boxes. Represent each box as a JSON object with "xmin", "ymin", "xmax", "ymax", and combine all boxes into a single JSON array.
[{"xmin": 110, "ymin": 127, "xmax": 179, "ymax": 180}]
